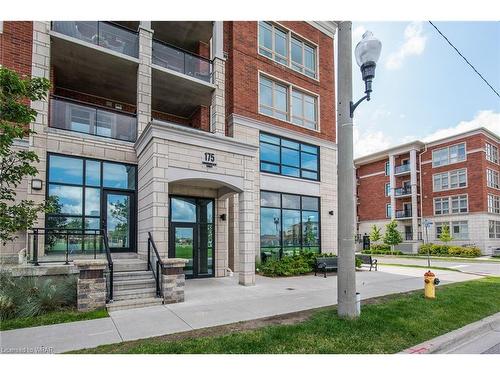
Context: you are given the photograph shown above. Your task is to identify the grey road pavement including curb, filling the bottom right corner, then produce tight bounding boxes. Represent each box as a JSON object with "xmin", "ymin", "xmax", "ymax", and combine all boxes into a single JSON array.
[{"xmin": 401, "ymin": 312, "xmax": 500, "ymax": 354}]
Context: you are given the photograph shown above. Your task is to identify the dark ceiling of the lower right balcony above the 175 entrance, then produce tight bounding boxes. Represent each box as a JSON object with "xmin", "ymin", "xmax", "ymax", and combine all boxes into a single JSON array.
[{"xmin": 152, "ymin": 68, "xmax": 214, "ymax": 117}]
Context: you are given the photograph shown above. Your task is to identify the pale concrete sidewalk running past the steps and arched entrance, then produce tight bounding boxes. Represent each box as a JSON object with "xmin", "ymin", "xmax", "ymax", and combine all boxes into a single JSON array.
[{"xmin": 0, "ymin": 266, "xmax": 480, "ymax": 353}]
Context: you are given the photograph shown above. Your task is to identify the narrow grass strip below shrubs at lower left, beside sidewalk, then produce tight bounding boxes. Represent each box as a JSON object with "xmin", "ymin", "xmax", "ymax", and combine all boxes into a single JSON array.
[{"xmin": 0, "ymin": 309, "xmax": 109, "ymax": 331}]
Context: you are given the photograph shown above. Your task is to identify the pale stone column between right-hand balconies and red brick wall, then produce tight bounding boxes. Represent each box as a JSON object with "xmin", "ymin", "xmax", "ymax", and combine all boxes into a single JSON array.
[{"xmin": 210, "ymin": 21, "xmax": 226, "ymax": 135}]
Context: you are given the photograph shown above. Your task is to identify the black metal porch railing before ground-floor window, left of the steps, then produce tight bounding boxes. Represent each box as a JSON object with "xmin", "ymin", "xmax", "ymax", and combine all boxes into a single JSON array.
[{"xmin": 28, "ymin": 228, "xmax": 104, "ymax": 266}]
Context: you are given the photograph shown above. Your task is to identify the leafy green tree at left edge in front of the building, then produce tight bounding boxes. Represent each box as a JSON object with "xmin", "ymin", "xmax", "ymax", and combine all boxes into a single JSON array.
[{"xmin": 0, "ymin": 67, "xmax": 50, "ymax": 244}]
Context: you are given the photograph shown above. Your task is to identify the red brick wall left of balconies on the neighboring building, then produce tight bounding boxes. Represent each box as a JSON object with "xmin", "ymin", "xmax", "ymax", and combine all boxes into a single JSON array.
[{"xmin": 356, "ymin": 159, "xmax": 391, "ymax": 221}]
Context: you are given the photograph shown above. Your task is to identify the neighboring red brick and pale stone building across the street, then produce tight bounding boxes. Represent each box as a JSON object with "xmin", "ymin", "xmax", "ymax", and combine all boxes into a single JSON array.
[{"xmin": 355, "ymin": 128, "xmax": 500, "ymax": 254}]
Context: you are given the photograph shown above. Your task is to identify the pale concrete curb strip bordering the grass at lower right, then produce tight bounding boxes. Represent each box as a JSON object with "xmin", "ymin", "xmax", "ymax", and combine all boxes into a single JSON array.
[{"xmin": 398, "ymin": 312, "xmax": 500, "ymax": 354}]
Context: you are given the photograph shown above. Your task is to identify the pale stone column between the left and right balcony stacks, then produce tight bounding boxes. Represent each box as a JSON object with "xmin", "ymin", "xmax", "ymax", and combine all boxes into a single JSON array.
[{"xmin": 137, "ymin": 21, "xmax": 153, "ymax": 136}]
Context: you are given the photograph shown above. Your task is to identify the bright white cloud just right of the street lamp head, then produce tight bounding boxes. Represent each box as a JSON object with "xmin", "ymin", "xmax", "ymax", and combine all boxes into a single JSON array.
[{"xmin": 385, "ymin": 22, "xmax": 427, "ymax": 70}]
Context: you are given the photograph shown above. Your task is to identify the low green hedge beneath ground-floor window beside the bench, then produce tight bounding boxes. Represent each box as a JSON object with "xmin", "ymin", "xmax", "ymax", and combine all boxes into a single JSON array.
[{"xmin": 257, "ymin": 251, "xmax": 361, "ymax": 277}]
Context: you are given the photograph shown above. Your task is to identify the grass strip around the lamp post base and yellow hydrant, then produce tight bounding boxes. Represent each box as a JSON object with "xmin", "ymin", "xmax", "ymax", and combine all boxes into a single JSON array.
[{"xmin": 75, "ymin": 277, "xmax": 500, "ymax": 354}]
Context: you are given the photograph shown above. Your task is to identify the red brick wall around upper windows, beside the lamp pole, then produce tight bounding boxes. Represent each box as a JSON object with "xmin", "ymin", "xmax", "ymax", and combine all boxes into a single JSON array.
[{"xmin": 224, "ymin": 21, "xmax": 335, "ymax": 141}]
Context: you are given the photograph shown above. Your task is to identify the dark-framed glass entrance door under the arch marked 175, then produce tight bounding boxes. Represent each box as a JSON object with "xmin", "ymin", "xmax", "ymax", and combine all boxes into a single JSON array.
[{"xmin": 168, "ymin": 196, "xmax": 215, "ymax": 278}]
